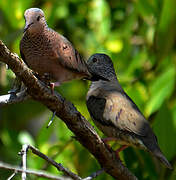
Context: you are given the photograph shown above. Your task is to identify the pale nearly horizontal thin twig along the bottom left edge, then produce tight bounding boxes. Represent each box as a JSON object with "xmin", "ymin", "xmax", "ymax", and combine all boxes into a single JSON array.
[{"xmin": 0, "ymin": 162, "xmax": 68, "ymax": 180}]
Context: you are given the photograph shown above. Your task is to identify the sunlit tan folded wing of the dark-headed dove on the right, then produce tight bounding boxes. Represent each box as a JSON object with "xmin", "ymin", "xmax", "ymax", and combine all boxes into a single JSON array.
[{"xmin": 103, "ymin": 91, "xmax": 151, "ymax": 136}]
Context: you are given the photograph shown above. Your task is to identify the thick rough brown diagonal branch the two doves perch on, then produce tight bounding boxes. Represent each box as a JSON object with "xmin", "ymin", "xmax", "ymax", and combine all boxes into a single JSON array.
[{"xmin": 0, "ymin": 41, "xmax": 137, "ymax": 180}]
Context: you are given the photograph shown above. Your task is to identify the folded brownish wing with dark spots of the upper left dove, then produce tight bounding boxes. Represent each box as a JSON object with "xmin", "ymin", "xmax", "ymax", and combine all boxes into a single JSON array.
[{"xmin": 55, "ymin": 34, "xmax": 90, "ymax": 75}]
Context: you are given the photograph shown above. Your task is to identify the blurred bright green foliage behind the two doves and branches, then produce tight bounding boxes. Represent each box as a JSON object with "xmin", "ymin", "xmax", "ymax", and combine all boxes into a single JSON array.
[{"xmin": 0, "ymin": 0, "xmax": 176, "ymax": 180}]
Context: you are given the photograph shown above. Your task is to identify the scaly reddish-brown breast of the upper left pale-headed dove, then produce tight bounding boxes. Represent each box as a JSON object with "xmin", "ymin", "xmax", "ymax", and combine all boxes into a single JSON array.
[{"xmin": 20, "ymin": 35, "xmax": 57, "ymax": 74}]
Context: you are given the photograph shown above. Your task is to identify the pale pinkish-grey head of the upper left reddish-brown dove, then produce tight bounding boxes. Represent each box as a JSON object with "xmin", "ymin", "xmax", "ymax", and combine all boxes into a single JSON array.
[{"xmin": 24, "ymin": 8, "xmax": 47, "ymax": 33}]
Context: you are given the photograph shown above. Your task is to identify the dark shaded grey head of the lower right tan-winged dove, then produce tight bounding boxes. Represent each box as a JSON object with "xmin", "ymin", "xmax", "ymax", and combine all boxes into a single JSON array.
[{"xmin": 87, "ymin": 53, "xmax": 116, "ymax": 81}]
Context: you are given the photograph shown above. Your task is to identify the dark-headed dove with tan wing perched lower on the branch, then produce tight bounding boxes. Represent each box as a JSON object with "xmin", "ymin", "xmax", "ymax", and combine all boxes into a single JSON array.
[{"xmin": 86, "ymin": 53, "xmax": 172, "ymax": 169}]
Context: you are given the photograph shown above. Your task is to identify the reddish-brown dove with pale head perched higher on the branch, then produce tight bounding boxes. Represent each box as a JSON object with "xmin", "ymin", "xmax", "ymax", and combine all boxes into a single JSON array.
[{"xmin": 20, "ymin": 8, "xmax": 91, "ymax": 88}]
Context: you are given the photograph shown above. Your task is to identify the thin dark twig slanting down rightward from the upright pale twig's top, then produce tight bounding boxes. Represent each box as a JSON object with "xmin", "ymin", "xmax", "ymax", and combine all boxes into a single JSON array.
[{"xmin": 28, "ymin": 145, "xmax": 82, "ymax": 180}]
